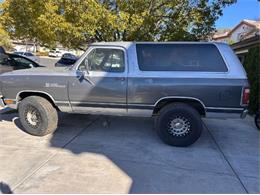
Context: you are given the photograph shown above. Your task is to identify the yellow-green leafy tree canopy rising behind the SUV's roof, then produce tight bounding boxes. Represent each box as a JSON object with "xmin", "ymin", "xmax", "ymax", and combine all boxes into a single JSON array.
[{"xmin": 0, "ymin": 0, "xmax": 235, "ymax": 48}]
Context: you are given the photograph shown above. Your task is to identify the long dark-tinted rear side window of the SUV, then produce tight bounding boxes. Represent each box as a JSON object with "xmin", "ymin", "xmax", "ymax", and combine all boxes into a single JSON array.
[{"xmin": 136, "ymin": 44, "xmax": 227, "ymax": 72}]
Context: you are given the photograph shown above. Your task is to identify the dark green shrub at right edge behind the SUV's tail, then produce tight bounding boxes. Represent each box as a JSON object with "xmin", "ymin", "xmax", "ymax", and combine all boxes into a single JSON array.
[{"xmin": 244, "ymin": 45, "xmax": 260, "ymax": 114}]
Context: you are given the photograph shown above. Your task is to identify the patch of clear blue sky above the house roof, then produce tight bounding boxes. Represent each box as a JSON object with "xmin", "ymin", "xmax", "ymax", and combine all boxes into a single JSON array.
[{"xmin": 216, "ymin": 0, "xmax": 260, "ymax": 28}]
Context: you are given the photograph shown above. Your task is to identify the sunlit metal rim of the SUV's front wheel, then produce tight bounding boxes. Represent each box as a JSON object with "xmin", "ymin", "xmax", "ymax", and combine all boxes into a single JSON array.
[{"xmin": 25, "ymin": 105, "xmax": 42, "ymax": 129}]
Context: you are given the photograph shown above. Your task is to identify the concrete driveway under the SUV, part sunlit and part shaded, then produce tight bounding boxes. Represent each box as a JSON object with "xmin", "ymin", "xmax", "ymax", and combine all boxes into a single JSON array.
[{"xmin": 0, "ymin": 109, "xmax": 260, "ymax": 193}]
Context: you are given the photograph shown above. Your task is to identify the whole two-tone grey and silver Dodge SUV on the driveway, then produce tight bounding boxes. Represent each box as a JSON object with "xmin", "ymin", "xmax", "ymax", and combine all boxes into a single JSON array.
[{"xmin": 0, "ymin": 42, "xmax": 249, "ymax": 146}]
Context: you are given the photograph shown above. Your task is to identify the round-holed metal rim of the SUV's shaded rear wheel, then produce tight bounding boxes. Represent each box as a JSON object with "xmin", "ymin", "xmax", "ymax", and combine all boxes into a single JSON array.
[{"xmin": 168, "ymin": 116, "xmax": 191, "ymax": 137}]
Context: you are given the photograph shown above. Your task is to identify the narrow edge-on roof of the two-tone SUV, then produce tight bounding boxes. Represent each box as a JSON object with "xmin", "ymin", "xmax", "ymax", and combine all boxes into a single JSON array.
[{"xmin": 90, "ymin": 41, "xmax": 226, "ymax": 48}]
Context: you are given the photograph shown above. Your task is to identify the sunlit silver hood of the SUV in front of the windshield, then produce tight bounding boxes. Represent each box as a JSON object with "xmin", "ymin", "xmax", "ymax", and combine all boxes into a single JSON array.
[{"xmin": 1, "ymin": 67, "xmax": 72, "ymax": 76}]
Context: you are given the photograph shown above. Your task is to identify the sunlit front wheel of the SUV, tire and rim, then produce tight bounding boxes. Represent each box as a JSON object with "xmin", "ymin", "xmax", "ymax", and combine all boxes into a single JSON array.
[{"xmin": 18, "ymin": 96, "xmax": 58, "ymax": 136}]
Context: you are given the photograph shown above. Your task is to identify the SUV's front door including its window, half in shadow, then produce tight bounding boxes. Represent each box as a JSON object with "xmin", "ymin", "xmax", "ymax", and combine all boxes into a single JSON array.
[{"xmin": 69, "ymin": 47, "xmax": 127, "ymax": 115}]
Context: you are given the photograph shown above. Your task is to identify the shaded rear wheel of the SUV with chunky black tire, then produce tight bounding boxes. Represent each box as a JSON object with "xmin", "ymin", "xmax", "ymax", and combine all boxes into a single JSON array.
[{"xmin": 155, "ymin": 103, "xmax": 203, "ymax": 147}]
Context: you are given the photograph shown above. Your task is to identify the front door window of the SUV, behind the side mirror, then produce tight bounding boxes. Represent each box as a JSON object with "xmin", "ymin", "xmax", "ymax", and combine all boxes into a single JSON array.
[{"xmin": 79, "ymin": 48, "xmax": 125, "ymax": 72}]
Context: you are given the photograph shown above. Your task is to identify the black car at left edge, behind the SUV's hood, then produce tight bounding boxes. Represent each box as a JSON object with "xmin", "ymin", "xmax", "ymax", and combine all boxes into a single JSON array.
[{"xmin": 0, "ymin": 53, "xmax": 44, "ymax": 74}]
